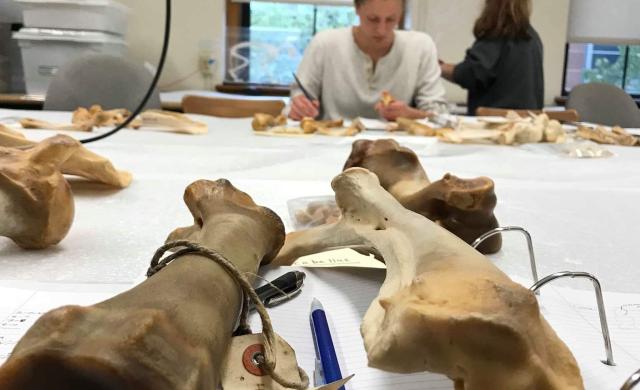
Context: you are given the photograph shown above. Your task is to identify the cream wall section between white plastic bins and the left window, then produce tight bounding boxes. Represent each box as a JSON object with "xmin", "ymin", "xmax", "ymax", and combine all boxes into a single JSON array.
[{"xmin": 118, "ymin": 0, "xmax": 225, "ymax": 90}]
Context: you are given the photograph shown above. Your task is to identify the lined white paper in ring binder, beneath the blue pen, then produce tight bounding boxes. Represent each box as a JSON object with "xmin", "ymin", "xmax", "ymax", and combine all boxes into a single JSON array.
[{"xmin": 252, "ymin": 267, "xmax": 640, "ymax": 390}]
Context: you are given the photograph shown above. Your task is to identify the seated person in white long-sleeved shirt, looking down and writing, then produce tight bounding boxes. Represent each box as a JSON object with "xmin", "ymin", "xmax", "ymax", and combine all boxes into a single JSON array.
[{"xmin": 288, "ymin": 0, "xmax": 447, "ymax": 120}]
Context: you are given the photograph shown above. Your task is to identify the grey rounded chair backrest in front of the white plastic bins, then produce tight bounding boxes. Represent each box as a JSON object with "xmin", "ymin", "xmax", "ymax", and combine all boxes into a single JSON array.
[{"xmin": 44, "ymin": 54, "xmax": 161, "ymax": 111}]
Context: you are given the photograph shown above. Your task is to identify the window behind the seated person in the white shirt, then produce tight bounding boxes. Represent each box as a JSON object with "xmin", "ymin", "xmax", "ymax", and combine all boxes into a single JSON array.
[{"xmin": 225, "ymin": 1, "xmax": 357, "ymax": 85}]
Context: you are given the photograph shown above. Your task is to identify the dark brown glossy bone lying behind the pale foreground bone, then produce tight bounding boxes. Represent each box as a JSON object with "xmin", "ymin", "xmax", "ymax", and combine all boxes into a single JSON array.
[{"xmin": 344, "ymin": 139, "xmax": 502, "ymax": 254}]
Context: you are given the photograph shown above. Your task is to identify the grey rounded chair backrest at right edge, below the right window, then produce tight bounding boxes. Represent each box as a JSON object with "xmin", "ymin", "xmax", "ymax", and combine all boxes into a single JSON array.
[{"xmin": 567, "ymin": 83, "xmax": 640, "ymax": 128}]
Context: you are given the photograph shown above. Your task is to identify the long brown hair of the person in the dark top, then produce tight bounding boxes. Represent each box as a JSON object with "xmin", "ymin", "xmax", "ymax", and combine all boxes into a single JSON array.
[{"xmin": 473, "ymin": 0, "xmax": 531, "ymax": 39}]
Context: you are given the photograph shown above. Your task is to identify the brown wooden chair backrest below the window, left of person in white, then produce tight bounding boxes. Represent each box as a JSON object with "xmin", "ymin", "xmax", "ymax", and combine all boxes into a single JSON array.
[{"xmin": 182, "ymin": 95, "xmax": 285, "ymax": 118}]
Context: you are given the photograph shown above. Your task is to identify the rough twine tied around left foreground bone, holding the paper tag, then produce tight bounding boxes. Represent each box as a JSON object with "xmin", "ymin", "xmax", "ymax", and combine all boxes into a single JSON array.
[{"xmin": 147, "ymin": 240, "xmax": 309, "ymax": 390}]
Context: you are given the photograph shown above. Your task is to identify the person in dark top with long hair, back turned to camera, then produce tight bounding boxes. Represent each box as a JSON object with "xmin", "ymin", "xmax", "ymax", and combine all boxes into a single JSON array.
[{"xmin": 440, "ymin": 0, "xmax": 544, "ymax": 115}]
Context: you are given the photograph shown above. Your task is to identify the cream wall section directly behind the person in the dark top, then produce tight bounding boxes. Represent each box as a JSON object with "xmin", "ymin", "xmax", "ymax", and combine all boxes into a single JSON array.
[{"xmin": 413, "ymin": 0, "xmax": 569, "ymax": 105}]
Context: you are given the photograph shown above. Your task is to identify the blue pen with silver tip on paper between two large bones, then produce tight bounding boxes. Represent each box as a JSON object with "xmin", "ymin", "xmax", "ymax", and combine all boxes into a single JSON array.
[{"xmin": 309, "ymin": 298, "xmax": 344, "ymax": 390}]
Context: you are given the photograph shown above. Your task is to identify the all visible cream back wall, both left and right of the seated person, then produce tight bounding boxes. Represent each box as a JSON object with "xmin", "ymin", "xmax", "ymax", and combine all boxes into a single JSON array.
[{"xmin": 120, "ymin": 0, "xmax": 569, "ymax": 100}]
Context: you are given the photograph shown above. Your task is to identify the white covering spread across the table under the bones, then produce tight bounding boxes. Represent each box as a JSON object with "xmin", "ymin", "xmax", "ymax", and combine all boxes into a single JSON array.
[{"xmin": 0, "ymin": 110, "xmax": 640, "ymax": 293}]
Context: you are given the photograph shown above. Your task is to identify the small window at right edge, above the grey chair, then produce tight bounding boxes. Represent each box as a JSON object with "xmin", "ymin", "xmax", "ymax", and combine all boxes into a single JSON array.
[{"xmin": 563, "ymin": 43, "xmax": 640, "ymax": 98}]
